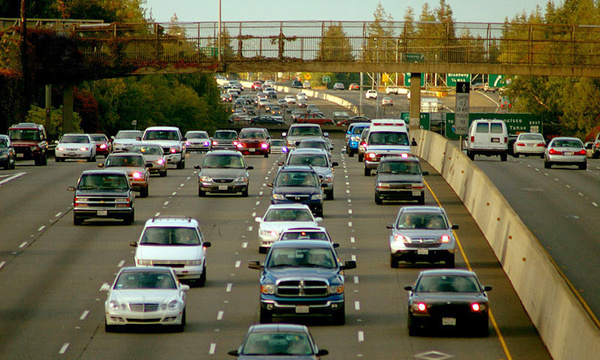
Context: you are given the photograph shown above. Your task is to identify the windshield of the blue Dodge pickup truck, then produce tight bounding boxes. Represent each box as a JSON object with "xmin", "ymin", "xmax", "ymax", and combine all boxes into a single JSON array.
[{"xmin": 266, "ymin": 247, "xmax": 336, "ymax": 269}]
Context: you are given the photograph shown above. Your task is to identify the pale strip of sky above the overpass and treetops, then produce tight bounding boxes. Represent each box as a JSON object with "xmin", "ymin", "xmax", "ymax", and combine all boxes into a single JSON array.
[{"xmin": 145, "ymin": 0, "xmax": 552, "ymax": 23}]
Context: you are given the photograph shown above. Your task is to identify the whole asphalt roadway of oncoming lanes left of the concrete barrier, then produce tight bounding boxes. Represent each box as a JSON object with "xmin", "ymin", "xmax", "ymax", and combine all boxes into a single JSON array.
[{"xmin": 0, "ymin": 139, "xmax": 550, "ymax": 360}]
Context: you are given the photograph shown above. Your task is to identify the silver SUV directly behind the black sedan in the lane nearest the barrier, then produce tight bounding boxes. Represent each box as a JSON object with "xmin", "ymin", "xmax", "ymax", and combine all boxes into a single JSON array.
[{"xmin": 387, "ymin": 205, "xmax": 458, "ymax": 268}]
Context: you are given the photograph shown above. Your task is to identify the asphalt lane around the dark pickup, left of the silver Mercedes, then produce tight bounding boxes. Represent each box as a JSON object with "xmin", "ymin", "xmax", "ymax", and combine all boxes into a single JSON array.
[{"xmin": 0, "ymin": 156, "xmax": 199, "ymax": 358}]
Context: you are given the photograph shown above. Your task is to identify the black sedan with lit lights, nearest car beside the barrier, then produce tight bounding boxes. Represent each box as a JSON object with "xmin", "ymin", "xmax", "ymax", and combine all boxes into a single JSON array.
[{"xmin": 404, "ymin": 269, "xmax": 492, "ymax": 337}]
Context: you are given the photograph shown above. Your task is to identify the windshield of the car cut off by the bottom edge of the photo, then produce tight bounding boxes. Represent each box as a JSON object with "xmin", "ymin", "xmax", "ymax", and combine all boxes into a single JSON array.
[{"xmin": 241, "ymin": 331, "xmax": 313, "ymax": 355}]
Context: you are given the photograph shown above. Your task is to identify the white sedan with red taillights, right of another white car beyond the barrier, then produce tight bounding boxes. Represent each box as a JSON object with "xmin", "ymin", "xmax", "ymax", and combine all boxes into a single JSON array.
[{"xmin": 544, "ymin": 137, "xmax": 587, "ymax": 170}]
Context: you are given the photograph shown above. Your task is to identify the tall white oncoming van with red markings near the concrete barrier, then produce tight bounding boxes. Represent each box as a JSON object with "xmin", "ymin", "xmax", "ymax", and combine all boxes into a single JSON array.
[{"xmin": 359, "ymin": 119, "xmax": 410, "ymax": 176}]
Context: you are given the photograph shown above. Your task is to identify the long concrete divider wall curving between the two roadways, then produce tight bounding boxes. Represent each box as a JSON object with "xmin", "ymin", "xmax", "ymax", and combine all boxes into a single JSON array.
[{"xmin": 411, "ymin": 130, "xmax": 600, "ymax": 360}]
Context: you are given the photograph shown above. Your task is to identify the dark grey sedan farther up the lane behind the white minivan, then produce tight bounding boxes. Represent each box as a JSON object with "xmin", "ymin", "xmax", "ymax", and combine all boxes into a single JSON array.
[{"xmin": 194, "ymin": 150, "xmax": 254, "ymax": 197}]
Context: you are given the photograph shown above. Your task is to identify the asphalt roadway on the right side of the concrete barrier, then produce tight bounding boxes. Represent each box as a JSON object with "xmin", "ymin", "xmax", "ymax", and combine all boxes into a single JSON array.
[{"xmin": 477, "ymin": 158, "xmax": 600, "ymax": 317}]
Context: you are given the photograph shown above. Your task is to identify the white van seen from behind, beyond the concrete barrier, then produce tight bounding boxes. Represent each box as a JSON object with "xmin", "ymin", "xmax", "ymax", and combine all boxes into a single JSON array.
[{"xmin": 467, "ymin": 119, "xmax": 508, "ymax": 161}]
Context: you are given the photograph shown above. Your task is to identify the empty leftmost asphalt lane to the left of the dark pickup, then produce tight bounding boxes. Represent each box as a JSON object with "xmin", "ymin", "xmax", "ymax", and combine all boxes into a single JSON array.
[{"xmin": 0, "ymin": 161, "xmax": 96, "ymax": 255}]
